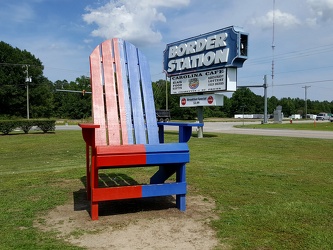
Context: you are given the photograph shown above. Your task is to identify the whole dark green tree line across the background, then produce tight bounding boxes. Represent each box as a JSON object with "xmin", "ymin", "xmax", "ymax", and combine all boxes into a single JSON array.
[{"xmin": 0, "ymin": 41, "xmax": 333, "ymax": 119}]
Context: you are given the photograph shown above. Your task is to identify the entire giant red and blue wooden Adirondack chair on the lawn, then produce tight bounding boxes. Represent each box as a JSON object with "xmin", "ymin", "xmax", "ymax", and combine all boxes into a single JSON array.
[{"xmin": 79, "ymin": 38, "xmax": 202, "ymax": 220}]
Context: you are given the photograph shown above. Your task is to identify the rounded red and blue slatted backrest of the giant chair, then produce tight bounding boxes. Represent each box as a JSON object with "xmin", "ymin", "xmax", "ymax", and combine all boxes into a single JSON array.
[{"xmin": 90, "ymin": 38, "xmax": 159, "ymax": 146}]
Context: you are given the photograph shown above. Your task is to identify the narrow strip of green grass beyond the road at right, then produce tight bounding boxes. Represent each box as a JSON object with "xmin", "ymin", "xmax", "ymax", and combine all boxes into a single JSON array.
[{"xmin": 235, "ymin": 121, "xmax": 333, "ymax": 131}]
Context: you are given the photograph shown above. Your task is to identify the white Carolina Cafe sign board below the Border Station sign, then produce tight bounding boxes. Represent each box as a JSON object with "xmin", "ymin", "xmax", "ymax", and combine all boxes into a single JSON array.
[{"xmin": 171, "ymin": 68, "xmax": 237, "ymax": 94}]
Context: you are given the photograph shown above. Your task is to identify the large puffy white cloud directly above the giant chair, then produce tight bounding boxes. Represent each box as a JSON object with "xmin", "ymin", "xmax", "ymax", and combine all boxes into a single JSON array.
[{"xmin": 83, "ymin": 0, "xmax": 190, "ymax": 46}]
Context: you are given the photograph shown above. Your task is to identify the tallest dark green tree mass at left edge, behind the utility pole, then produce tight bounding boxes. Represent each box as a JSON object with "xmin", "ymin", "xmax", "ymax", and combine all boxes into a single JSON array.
[{"xmin": 0, "ymin": 41, "xmax": 48, "ymax": 117}]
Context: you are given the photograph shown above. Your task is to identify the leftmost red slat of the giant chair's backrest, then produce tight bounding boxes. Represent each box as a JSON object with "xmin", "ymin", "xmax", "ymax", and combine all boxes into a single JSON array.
[{"xmin": 89, "ymin": 46, "xmax": 106, "ymax": 145}]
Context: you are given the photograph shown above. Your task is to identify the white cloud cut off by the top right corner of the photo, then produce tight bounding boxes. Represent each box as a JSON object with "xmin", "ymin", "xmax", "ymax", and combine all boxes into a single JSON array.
[{"xmin": 307, "ymin": 0, "xmax": 333, "ymax": 24}]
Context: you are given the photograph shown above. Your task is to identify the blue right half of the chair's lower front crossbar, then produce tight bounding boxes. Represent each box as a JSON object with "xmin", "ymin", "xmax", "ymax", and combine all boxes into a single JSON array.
[{"xmin": 142, "ymin": 182, "xmax": 186, "ymax": 197}]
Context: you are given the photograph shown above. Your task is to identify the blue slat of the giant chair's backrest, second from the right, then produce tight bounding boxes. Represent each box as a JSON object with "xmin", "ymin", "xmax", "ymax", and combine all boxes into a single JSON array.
[{"xmin": 125, "ymin": 42, "xmax": 147, "ymax": 144}]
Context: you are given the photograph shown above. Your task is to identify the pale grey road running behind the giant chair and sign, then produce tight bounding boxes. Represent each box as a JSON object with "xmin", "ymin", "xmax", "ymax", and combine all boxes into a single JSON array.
[{"xmin": 56, "ymin": 122, "xmax": 333, "ymax": 140}]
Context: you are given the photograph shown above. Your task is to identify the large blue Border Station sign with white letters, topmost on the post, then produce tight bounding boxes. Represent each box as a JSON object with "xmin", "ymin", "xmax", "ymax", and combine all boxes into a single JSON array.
[{"xmin": 163, "ymin": 26, "xmax": 248, "ymax": 76}]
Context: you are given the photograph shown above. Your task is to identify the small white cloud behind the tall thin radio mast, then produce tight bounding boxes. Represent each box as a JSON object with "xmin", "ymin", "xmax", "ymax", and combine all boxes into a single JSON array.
[{"xmin": 251, "ymin": 10, "xmax": 301, "ymax": 29}]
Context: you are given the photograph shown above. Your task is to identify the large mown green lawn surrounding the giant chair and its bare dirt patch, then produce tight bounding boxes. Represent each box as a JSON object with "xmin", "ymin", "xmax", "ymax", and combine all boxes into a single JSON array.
[{"xmin": 0, "ymin": 130, "xmax": 333, "ymax": 250}]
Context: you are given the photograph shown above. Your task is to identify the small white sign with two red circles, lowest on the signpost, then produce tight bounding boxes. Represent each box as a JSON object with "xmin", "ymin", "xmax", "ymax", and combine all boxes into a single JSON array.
[{"xmin": 179, "ymin": 94, "xmax": 223, "ymax": 108}]
